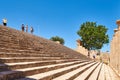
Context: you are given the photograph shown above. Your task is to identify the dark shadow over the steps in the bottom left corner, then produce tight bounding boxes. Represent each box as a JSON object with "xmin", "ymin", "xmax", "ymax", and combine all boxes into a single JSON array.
[{"xmin": 0, "ymin": 59, "xmax": 35, "ymax": 80}]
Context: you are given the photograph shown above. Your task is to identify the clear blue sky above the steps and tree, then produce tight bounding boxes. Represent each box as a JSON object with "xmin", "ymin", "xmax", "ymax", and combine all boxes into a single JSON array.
[{"xmin": 0, "ymin": 0, "xmax": 120, "ymax": 51}]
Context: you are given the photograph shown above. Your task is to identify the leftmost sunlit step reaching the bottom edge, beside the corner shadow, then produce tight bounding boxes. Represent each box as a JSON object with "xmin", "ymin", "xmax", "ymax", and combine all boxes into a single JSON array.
[{"xmin": 18, "ymin": 62, "xmax": 95, "ymax": 80}]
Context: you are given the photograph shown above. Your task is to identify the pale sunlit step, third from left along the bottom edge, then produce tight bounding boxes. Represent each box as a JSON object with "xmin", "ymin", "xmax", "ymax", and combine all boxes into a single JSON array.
[{"xmin": 74, "ymin": 63, "xmax": 99, "ymax": 80}]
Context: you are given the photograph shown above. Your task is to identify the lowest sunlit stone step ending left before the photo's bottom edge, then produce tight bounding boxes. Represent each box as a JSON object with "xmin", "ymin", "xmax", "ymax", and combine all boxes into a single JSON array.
[{"xmin": 17, "ymin": 61, "xmax": 85, "ymax": 76}]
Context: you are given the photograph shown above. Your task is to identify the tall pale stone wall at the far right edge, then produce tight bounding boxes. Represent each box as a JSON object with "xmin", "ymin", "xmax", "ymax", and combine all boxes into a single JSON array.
[{"xmin": 110, "ymin": 20, "xmax": 120, "ymax": 74}]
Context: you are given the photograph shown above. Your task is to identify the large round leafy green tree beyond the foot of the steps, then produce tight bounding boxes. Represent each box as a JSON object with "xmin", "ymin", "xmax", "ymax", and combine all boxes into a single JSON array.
[{"xmin": 77, "ymin": 22, "xmax": 109, "ymax": 50}]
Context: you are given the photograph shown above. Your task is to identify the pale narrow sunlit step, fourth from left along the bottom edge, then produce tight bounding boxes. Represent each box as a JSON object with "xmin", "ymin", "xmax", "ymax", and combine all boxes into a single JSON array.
[{"xmin": 88, "ymin": 63, "xmax": 103, "ymax": 80}]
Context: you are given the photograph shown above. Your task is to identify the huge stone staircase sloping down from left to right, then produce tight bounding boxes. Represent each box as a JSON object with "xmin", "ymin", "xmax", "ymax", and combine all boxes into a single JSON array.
[{"xmin": 0, "ymin": 26, "xmax": 120, "ymax": 80}]
